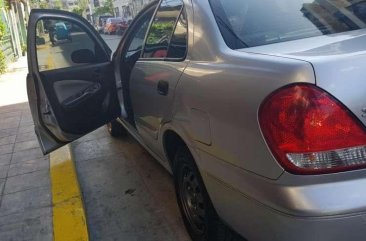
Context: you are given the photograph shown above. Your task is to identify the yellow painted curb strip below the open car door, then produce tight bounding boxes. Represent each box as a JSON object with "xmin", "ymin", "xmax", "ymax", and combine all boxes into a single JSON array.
[{"xmin": 50, "ymin": 146, "xmax": 89, "ymax": 241}]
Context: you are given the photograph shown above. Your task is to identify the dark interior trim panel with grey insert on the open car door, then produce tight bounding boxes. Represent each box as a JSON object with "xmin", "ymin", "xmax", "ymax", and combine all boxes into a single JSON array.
[{"xmin": 41, "ymin": 63, "xmax": 119, "ymax": 134}]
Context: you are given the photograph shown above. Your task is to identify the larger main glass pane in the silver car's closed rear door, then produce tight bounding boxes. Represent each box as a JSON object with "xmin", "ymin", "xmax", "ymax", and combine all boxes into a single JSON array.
[{"xmin": 144, "ymin": 0, "xmax": 183, "ymax": 58}]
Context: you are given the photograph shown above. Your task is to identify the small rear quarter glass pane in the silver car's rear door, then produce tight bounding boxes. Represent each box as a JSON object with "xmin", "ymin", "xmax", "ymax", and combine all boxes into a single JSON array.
[{"xmin": 168, "ymin": 11, "xmax": 188, "ymax": 59}]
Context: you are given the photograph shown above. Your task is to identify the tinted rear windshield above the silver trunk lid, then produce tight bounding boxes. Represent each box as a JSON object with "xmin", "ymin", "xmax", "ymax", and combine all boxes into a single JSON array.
[{"xmin": 210, "ymin": 0, "xmax": 366, "ymax": 49}]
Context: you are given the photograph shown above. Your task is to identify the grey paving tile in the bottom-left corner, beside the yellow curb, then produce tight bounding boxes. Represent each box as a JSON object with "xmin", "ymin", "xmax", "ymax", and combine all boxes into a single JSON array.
[{"xmin": 0, "ymin": 208, "xmax": 53, "ymax": 241}]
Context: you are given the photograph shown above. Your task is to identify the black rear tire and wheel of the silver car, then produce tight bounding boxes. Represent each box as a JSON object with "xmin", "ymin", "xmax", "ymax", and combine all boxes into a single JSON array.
[{"xmin": 173, "ymin": 147, "xmax": 245, "ymax": 241}]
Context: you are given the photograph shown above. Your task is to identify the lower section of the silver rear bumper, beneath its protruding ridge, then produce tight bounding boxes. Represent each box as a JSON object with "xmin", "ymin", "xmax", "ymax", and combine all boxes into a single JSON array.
[{"xmin": 205, "ymin": 173, "xmax": 366, "ymax": 241}]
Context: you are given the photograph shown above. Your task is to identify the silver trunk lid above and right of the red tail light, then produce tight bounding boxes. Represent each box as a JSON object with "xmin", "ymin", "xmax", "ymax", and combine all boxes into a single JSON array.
[{"xmin": 239, "ymin": 30, "xmax": 366, "ymax": 125}]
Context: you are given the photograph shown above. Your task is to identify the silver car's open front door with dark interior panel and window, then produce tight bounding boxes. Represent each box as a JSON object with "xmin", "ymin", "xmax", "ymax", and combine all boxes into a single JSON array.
[{"xmin": 27, "ymin": 9, "xmax": 121, "ymax": 154}]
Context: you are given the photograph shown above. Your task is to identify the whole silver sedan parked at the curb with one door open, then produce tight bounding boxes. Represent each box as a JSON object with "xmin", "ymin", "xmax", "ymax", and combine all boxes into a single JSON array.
[{"xmin": 27, "ymin": 0, "xmax": 366, "ymax": 241}]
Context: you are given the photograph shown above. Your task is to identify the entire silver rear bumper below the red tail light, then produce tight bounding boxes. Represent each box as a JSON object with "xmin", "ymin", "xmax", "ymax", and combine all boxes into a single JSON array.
[{"xmin": 198, "ymin": 152, "xmax": 366, "ymax": 241}]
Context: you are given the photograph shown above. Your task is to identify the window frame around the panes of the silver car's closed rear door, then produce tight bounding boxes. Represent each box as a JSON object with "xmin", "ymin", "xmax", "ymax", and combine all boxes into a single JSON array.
[{"xmin": 138, "ymin": 0, "xmax": 189, "ymax": 62}]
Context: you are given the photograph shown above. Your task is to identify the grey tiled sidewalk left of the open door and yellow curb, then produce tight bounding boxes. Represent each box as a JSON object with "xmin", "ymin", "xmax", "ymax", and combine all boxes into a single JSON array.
[{"xmin": 0, "ymin": 57, "xmax": 53, "ymax": 241}]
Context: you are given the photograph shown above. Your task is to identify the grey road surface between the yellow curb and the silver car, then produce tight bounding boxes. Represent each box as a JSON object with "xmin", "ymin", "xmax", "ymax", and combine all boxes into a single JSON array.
[{"xmin": 72, "ymin": 127, "xmax": 191, "ymax": 241}]
